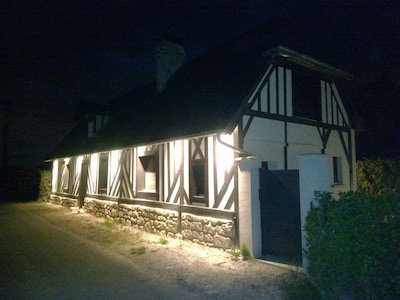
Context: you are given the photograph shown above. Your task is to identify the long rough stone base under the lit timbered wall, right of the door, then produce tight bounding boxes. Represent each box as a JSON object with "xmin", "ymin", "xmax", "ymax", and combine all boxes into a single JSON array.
[{"xmin": 84, "ymin": 200, "xmax": 234, "ymax": 249}]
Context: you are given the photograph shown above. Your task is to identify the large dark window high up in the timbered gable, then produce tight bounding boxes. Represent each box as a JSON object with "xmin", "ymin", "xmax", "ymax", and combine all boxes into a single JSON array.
[{"xmin": 292, "ymin": 71, "xmax": 322, "ymax": 121}]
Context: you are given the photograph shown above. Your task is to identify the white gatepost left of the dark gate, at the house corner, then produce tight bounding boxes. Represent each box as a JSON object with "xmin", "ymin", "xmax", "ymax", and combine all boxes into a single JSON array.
[{"xmin": 238, "ymin": 159, "xmax": 262, "ymax": 257}]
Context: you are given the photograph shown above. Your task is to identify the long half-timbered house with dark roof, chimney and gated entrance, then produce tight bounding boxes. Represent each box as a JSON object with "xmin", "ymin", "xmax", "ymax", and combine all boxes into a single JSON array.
[{"xmin": 51, "ymin": 24, "xmax": 356, "ymax": 266}]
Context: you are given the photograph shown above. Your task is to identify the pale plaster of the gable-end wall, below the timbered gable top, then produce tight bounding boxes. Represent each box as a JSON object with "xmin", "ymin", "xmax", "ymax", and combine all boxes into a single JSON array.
[{"xmin": 244, "ymin": 118, "xmax": 356, "ymax": 194}]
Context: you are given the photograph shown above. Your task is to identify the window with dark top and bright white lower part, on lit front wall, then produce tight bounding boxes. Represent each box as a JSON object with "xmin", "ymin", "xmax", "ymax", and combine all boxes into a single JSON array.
[{"xmin": 136, "ymin": 146, "xmax": 159, "ymax": 199}]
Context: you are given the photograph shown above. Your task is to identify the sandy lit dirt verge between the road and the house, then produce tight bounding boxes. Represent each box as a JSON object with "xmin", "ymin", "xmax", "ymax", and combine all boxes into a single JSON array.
[{"xmin": 20, "ymin": 203, "xmax": 288, "ymax": 299}]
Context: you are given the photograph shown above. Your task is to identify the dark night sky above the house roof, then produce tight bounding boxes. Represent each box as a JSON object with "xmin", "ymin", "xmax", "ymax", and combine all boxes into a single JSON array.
[{"xmin": 0, "ymin": 0, "xmax": 400, "ymax": 166}]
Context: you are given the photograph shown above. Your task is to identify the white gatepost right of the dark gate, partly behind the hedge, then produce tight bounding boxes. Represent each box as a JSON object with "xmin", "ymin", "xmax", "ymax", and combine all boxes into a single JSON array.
[{"xmin": 298, "ymin": 154, "xmax": 330, "ymax": 271}]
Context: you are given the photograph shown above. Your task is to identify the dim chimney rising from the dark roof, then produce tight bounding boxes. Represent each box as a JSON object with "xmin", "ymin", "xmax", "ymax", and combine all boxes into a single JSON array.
[{"xmin": 155, "ymin": 35, "xmax": 185, "ymax": 93}]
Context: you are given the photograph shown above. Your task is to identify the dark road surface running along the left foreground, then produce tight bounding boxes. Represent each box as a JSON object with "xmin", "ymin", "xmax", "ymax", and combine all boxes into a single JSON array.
[{"xmin": 0, "ymin": 204, "xmax": 198, "ymax": 299}]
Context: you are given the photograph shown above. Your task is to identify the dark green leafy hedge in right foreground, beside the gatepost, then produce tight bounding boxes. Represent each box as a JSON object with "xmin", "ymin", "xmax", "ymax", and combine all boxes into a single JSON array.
[{"xmin": 305, "ymin": 192, "xmax": 400, "ymax": 299}]
